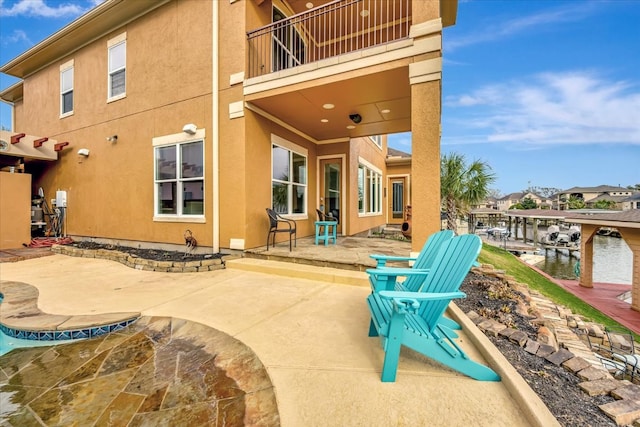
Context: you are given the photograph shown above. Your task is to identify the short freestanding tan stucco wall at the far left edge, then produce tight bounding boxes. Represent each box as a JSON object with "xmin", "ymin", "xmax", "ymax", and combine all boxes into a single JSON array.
[{"xmin": 0, "ymin": 171, "xmax": 31, "ymax": 249}]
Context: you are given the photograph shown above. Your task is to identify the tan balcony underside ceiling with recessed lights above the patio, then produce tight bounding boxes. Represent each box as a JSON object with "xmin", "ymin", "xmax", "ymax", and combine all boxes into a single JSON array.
[{"xmin": 248, "ymin": 67, "xmax": 411, "ymax": 143}]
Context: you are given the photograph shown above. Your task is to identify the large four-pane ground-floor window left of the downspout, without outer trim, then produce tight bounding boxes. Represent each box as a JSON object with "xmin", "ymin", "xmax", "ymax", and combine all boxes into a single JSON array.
[{"xmin": 155, "ymin": 141, "xmax": 204, "ymax": 216}]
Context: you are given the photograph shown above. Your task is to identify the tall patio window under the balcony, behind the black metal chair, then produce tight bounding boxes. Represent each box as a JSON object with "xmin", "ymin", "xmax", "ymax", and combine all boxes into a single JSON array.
[{"xmin": 271, "ymin": 144, "xmax": 307, "ymax": 215}]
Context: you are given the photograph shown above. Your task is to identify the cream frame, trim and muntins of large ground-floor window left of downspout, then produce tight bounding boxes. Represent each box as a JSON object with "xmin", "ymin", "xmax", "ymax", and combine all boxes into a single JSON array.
[{"xmin": 152, "ymin": 129, "xmax": 207, "ymax": 223}]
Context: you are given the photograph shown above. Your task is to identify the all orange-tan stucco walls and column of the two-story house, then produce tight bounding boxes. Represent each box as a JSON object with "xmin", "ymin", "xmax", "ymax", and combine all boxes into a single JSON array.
[{"xmin": 10, "ymin": 0, "xmax": 450, "ymax": 252}]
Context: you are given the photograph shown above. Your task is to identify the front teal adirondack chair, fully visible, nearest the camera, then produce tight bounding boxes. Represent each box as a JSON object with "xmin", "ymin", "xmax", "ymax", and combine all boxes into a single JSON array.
[{"xmin": 367, "ymin": 234, "xmax": 500, "ymax": 382}]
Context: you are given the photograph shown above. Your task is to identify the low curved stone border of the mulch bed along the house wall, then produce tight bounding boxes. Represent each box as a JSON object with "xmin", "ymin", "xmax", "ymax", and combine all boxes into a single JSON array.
[{"xmin": 51, "ymin": 245, "xmax": 238, "ymax": 273}]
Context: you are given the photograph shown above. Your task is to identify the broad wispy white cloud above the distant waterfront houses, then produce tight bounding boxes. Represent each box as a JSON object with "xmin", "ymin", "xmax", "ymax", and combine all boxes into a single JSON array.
[{"xmin": 443, "ymin": 72, "xmax": 640, "ymax": 148}]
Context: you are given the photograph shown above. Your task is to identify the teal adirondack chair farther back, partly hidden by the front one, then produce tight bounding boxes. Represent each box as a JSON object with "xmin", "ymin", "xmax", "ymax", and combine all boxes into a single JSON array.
[{"xmin": 367, "ymin": 230, "xmax": 454, "ymax": 292}]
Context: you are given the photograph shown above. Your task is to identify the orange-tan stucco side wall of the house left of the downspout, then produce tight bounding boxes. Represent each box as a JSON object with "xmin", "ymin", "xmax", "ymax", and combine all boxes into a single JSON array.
[{"xmin": 16, "ymin": 1, "xmax": 214, "ymax": 246}]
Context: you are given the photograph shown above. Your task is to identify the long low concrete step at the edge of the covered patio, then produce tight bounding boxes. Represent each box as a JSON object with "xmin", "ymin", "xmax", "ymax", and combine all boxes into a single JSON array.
[{"xmin": 225, "ymin": 258, "xmax": 369, "ymax": 287}]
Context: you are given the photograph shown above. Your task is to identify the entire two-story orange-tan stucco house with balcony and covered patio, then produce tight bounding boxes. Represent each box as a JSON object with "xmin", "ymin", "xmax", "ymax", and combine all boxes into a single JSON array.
[{"xmin": 0, "ymin": 0, "xmax": 457, "ymax": 251}]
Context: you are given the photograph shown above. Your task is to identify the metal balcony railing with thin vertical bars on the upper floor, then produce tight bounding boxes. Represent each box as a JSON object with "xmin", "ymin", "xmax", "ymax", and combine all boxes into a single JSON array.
[{"xmin": 247, "ymin": 0, "xmax": 411, "ymax": 78}]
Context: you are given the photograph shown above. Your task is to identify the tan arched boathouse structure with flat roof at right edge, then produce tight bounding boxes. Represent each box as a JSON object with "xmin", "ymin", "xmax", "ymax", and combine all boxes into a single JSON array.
[{"xmin": 566, "ymin": 209, "xmax": 640, "ymax": 311}]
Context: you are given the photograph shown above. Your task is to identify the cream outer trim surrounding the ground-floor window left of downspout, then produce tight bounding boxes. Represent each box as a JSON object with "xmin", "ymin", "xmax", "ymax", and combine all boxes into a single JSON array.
[{"xmin": 152, "ymin": 129, "xmax": 207, "ymax": 224}]
